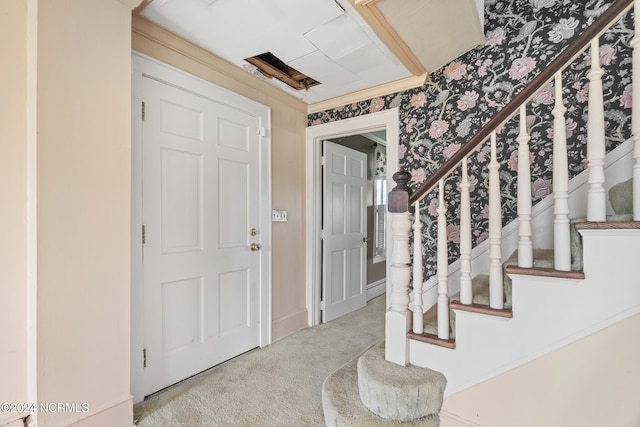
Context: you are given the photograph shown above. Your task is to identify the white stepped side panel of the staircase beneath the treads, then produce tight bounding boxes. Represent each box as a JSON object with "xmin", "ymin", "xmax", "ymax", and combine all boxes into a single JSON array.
[{"xmin": 409, "ymin": 230, "xmax": 640, "ymax": 396}]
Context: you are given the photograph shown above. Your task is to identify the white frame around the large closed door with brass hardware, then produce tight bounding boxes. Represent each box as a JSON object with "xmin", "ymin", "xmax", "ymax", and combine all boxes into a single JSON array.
[{"xmin": 131, "ymin": 51, "xmax": 272, "ymax": 403}]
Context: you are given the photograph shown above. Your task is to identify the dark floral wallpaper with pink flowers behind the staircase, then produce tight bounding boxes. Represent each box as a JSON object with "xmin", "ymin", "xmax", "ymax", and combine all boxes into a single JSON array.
[{"xmin": 308, "ymin": 0, "xmax": 633, "ymax": 280}]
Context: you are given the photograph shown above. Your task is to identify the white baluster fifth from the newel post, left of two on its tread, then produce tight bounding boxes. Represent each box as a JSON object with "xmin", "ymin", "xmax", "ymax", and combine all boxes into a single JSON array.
[{"xmin": 516, "ymin": 104, "xmax": 533, "ymax": 267}]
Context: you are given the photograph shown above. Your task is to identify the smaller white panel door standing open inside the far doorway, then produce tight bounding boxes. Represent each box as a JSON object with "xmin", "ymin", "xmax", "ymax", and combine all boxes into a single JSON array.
[{"xmin": 322, "ymin": 141, "xmax": 367, "ymax": 322}]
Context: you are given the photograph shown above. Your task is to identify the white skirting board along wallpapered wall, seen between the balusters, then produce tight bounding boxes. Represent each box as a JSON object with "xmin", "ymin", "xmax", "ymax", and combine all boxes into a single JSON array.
[{"xmin": 410, "ymin": 138, "xmax": 634, "ymax": 311}]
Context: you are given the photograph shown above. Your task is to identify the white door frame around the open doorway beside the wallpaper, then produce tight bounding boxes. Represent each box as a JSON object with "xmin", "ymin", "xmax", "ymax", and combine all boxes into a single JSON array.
[{"xmin": 305, "ymin": 108, "xmax": 399, "ymax": 326}]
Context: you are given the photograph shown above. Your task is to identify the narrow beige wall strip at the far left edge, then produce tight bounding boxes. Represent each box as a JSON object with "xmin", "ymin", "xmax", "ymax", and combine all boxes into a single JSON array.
[{"xmin": 0, "ymin": 0, "xmax": 28, "ymax": 425}]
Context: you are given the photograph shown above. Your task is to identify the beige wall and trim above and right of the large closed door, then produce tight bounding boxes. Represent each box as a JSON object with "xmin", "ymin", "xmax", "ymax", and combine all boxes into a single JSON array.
[{"xmin": 132, "ymin": 17, "xmax": 307, "ymax": 340}]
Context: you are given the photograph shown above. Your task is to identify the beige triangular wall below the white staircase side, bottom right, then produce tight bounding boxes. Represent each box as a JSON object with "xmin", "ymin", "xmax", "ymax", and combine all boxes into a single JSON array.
[{"xmin": 441, "ymin": 315, "xmax": 640, "ymax": 427}]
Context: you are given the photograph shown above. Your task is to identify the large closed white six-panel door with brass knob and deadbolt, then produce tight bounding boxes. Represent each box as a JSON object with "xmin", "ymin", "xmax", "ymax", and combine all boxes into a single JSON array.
[{"xmin": 142, "ymin": 77, "xmax": 260, "ymax": 395}]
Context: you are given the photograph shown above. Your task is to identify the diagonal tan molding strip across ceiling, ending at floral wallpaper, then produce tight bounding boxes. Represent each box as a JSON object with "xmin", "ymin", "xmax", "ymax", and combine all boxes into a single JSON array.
[{"xmin": 349, "ymin": 0, "xmax": 428, "ymax": 76}]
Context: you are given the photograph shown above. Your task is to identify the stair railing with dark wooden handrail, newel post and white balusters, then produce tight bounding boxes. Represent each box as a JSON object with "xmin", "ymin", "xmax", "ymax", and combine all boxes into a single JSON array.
[{"xmin": 385, "ymin": 0, "xmax": 640, "ymax": 365}]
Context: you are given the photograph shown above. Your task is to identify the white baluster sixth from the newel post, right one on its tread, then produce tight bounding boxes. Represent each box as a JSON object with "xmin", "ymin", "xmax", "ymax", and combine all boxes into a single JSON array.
[{"xmin": 553, "ymin": 73, "xmax": 571, "ymax": 271}]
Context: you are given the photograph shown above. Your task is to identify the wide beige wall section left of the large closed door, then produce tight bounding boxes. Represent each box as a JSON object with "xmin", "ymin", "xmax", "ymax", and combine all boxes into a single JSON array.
[{"xmin": 37, "ymin": 0, "xmax": 134, "ymax": 426}]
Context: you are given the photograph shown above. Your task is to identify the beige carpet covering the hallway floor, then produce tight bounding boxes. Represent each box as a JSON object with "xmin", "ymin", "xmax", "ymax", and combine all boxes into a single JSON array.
[{"xmin": 134, "ymin": 296, "xmax": 385, "ymax": 427}]
